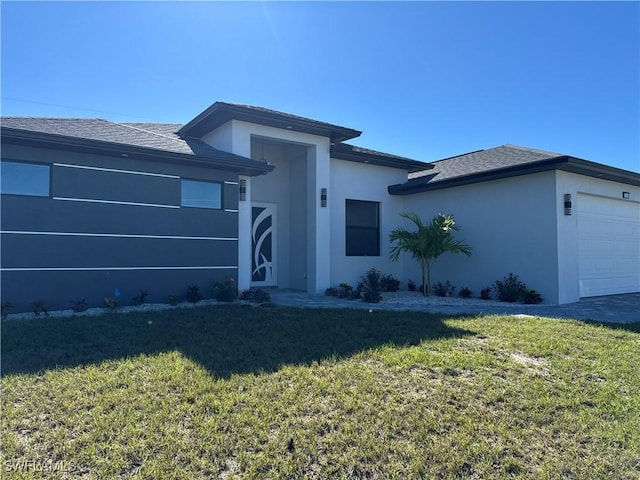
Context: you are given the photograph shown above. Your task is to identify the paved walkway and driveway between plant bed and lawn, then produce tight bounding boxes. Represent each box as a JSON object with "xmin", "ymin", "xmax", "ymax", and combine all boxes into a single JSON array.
[{"xmin": 269, "ymin": 289, "xmax": 640, "ymax": 323}]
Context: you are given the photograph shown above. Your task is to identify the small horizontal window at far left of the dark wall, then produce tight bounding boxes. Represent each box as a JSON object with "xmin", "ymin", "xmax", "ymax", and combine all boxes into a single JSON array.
[{"xmin": 0, "ymin": 162, "xmax": 50, "ymax": 197}]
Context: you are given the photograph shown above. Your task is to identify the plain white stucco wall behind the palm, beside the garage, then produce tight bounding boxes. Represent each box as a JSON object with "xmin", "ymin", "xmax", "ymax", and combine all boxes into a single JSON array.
[{"xmin": 404, "ymin": 172, "xmax": 559, "ymax": 303}]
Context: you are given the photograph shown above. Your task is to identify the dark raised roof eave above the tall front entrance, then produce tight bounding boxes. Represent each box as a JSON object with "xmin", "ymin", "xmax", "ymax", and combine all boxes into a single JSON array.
[{"xmin": 178, "ymin": 102, "xmax": 362, "ymax": 142}]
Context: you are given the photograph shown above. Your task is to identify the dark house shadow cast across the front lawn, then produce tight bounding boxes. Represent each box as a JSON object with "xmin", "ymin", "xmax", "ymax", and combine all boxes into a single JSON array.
[{"xmin": 2, "ymin": 305, "xmax": 472, "ymax": 377}]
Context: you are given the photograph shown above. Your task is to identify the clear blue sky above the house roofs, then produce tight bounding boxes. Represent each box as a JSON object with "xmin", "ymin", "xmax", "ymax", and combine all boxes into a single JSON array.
[{"xmin": 1, "ymin": 1, "xmax": 640, "ymax": 171}]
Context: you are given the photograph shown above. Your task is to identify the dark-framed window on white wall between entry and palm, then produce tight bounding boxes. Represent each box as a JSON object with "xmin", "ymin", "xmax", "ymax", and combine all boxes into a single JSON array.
[{"xmin": 346, "ymin": 200, "xmax": 380, "ymax": 257}]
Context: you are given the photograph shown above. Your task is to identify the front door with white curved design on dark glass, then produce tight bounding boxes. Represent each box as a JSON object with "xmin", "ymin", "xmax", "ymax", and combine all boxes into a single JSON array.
[{"xmin": 251, "ymin": 203, "xmax": 278, "ymax": 286}]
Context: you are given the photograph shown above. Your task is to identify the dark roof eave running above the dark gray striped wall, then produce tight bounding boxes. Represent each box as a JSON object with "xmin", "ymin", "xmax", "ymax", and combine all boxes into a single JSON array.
[{"xmin": 0, "ymin": 127, "xmax": 274, "ymax": 176}]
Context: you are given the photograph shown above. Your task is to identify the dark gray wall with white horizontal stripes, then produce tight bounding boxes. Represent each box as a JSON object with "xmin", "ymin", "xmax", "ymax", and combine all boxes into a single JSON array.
[{"xmin": 1, "ymin": 145, "xmax": 238, "ymax": 311}]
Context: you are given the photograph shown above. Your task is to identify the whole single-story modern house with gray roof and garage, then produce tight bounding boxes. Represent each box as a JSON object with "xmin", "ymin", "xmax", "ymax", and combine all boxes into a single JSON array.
[{"xmin": 1, "ymin": 102, "xmax": 640, "ymax": 310}]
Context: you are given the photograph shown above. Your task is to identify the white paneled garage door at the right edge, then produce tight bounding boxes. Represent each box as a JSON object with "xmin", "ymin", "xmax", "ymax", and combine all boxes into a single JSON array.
[{"xmin": 576, "ymin": 194, "xmax": 640, "ymax": 297}]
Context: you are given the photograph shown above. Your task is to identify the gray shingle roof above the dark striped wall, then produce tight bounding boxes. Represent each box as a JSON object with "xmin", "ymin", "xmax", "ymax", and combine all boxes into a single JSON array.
[{"xmin": 1, "ymin": 117, "xmax": 272, "ymax": 173}]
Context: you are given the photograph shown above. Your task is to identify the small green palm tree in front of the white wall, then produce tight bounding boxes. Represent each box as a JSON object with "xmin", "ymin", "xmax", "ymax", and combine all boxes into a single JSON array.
[{"xmin": 389, "ymin": 212, "xmax": 471, "ymax": 296}]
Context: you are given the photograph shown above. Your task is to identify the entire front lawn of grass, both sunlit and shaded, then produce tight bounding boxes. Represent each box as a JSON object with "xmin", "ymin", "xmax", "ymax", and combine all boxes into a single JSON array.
[{"xmin": 1, "ymin": 305, "xmax": 640, "ymax": 479}]
